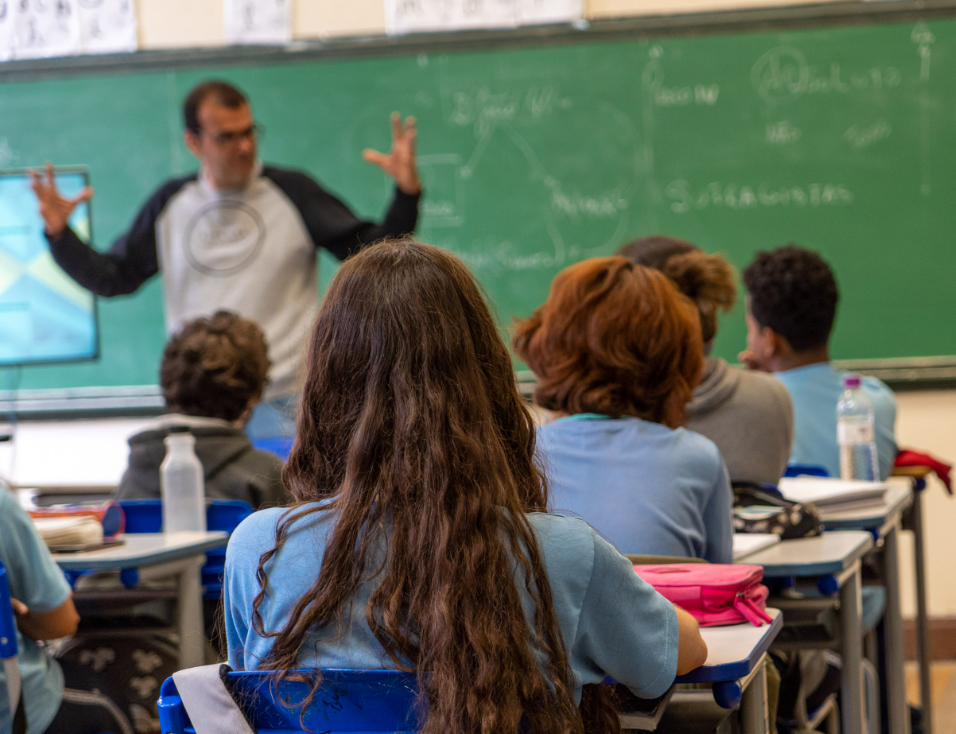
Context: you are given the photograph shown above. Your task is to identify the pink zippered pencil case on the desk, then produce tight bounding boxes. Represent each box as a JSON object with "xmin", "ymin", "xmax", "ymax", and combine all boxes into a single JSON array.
[{"xmin": 634, "ymin": 563, "xmax": 772, "ymax": 627}]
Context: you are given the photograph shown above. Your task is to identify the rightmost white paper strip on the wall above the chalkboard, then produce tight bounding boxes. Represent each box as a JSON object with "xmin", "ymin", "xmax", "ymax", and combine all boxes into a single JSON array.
[{"xmin": 385, "ymin": 0, "xmax": 518, "ymax": 35}]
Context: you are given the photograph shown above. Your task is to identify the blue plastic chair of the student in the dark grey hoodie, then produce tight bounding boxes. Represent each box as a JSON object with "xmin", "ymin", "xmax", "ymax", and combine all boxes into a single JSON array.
[{"xmin": 119, "ymin": 499, "xmax": 253, "ymax": 600}]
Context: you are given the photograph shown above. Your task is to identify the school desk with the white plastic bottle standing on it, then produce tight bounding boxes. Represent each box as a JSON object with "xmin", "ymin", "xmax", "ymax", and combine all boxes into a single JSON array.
[{"xmin": 53, "ymin": 531, "xmax": 229, "ymax": 668}]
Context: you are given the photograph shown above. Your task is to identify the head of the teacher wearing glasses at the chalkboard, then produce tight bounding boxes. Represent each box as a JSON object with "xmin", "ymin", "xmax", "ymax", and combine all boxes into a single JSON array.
[{"xmin": 183, "ymin": 81, "xmax": 257, "ymax": 190}]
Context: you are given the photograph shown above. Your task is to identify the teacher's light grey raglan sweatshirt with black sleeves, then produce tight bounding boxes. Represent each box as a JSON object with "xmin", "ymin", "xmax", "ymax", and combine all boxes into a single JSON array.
[{"xmin": 50, "ymin": 164, "xmax": 419, "ymax": 398}]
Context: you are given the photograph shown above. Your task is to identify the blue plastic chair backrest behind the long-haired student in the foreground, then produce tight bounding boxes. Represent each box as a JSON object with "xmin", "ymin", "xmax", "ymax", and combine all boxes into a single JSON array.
[{"xmin": 159, "ymin": 670, "xmax": 420, "ymax": 734}]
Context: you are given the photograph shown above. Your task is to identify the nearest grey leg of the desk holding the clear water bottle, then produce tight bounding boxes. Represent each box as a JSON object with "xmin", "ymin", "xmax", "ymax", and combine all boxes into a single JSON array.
[{"xmin": 882, "ymin": 523, "xmax": 910, "ymax": 734}]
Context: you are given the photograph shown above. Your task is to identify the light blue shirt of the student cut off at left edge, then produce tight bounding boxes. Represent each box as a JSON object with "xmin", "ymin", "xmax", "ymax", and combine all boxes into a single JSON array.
[{"xmin": 0, "ymin": 487, "xmax": 70, "ymax": 734}]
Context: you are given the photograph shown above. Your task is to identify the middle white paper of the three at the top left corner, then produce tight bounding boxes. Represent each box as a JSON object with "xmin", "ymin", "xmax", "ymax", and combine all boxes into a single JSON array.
[{"xmin": 7, "ymin": 0, "xmax": 80, "ymax": 59}]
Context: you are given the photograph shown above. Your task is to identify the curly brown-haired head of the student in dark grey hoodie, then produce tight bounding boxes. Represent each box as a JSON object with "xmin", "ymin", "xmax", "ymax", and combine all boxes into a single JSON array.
[{"xmin": 159, "ymin": 311, "xmax": 270, "ymax": 424}]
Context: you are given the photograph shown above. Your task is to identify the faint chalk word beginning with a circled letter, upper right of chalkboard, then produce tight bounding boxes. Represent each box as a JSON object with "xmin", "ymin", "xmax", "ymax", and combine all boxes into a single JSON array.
[{"xmin": 750, "ymin": 46, "xmax": 903, "ymax": 101}]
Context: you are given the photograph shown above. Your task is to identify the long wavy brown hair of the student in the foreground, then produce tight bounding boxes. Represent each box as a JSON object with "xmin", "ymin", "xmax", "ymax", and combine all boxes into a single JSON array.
[{"xmin": 254, "ymin": 239, "xmax": 608, "ymax": 734}]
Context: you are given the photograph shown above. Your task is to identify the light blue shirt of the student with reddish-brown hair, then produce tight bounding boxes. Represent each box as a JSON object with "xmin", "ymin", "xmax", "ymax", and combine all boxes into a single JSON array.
[{"xmin": 538, "ymin": 414, "xmax": 734, "ymax": 563}]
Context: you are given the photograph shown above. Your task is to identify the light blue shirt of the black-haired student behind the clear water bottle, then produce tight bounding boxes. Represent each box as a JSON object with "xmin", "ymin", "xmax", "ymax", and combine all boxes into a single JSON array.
[{"xmin": 774, "ymin": 362, "xmax": 897, "ymax": 479}]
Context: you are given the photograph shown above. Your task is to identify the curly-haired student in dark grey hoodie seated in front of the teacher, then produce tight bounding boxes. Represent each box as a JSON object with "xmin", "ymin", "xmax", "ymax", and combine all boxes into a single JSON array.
[{"xmin": 117, "ymin": 311, "xmax": 287, "ymax": 509}]
